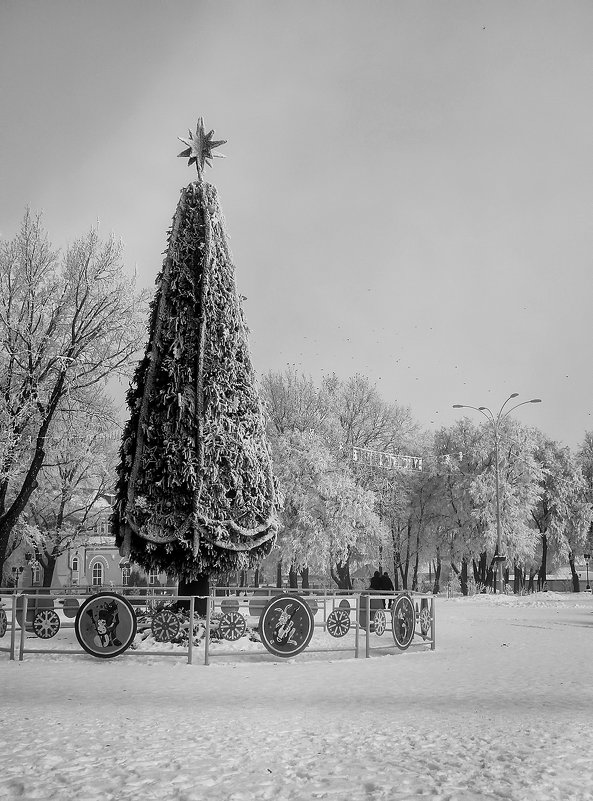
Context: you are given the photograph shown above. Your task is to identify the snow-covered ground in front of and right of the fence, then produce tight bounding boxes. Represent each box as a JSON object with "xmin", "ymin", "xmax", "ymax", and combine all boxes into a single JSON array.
[{"xmin": 0, "ymin": 593, "xmax": 593, "ymax": 801}]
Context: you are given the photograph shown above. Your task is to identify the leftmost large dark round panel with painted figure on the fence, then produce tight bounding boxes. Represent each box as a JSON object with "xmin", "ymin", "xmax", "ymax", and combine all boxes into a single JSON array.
[{"xmin": 74, "ymin": 592, "xmax": 136, "ymax": 659}]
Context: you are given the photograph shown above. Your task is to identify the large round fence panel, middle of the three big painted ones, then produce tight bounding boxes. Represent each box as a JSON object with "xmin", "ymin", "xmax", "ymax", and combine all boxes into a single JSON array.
[{"xmin": 259, "ymin": 595, "xmax": 315, "ymax": 657}]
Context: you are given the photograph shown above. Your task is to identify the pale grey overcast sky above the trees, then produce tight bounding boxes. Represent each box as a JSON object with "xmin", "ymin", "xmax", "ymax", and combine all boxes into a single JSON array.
[{"xmin": 0, "ymin": 0, "xmax": 593, "ymax": 448}]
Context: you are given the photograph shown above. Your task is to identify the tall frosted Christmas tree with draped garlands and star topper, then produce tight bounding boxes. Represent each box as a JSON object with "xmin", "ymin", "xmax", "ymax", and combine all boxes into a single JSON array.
[{"xmin": 113, "ymin": 119, "xmax": 278, "ymax": 580}]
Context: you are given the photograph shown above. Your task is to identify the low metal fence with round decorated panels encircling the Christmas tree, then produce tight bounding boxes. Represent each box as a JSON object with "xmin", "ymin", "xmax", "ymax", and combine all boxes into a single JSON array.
[{"xmin": 0, "ymin": 587, "xmax": 436, "ymax": 665}]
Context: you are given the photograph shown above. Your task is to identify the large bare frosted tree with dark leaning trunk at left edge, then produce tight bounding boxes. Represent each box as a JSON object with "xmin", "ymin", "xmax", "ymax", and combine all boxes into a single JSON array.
[{"xmin": 0, "ymin": 210, "xmax": 145, "ymax": 576}]
